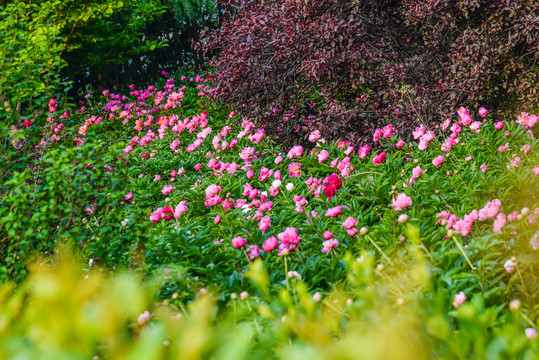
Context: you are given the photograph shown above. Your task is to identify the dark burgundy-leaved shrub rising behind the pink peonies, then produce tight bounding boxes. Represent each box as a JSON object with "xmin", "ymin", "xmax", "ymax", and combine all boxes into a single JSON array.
[{"xmin": 204, "ymin": 0, "xmax": 539, "ymax": 144}]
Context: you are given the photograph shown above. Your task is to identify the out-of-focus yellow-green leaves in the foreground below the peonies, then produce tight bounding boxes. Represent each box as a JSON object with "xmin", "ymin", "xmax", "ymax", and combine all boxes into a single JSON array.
[{"xmin": 0, "ymin": 249, "xmax": 539, "ymax": 360}]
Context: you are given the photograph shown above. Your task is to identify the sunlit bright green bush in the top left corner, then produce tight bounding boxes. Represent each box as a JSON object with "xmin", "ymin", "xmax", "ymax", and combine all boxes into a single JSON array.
[{"xmin": 0, "ymin": 2, "xmax": 66, "ymax": 119}]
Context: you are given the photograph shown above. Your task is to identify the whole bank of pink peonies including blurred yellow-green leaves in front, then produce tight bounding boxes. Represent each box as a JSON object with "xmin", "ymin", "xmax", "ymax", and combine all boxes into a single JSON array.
[{"xmin": 0, "ymin": 72, "xmax": 539, "ymax": 359}]
